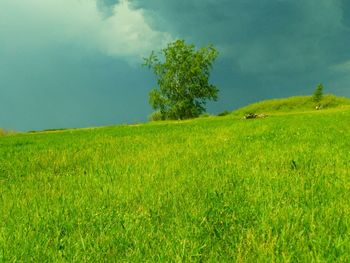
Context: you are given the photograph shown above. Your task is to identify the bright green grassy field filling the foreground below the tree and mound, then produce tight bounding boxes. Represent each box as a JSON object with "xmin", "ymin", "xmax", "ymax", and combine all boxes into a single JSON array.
[{"xmin": 0, "ymin": 101, "xmax": 350, "ymax": 262}]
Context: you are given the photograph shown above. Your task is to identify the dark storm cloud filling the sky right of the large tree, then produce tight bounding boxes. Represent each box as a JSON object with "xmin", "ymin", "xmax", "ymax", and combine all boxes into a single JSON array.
[{"xmin": 128, "ymin": 0, "xmax": 350, "ymax": 110}]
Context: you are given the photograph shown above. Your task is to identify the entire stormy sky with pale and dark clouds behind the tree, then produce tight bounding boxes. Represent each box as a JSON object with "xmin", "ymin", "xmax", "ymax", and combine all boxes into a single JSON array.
[{"xmin": 0, "ymin": 0, "xmax": 350, "ymax": 131}]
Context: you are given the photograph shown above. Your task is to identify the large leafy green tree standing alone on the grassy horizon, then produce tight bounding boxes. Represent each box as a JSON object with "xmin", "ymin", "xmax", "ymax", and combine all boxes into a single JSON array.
[{"xmin": 144, "ymin": 40, "xmax": 218, "ymax": 120}]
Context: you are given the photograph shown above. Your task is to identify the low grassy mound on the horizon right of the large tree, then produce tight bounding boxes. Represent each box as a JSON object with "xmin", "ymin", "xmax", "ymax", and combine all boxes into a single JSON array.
[{"xmin": 233, "ymin": 94, "xmax": 350, "ymax": 115}]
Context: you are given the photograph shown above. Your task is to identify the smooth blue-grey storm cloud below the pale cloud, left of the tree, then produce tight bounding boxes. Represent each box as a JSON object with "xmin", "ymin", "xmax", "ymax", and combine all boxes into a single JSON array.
[{"xmin": 0, "ymin": 46, "xmax": 152, "ymax": 133}]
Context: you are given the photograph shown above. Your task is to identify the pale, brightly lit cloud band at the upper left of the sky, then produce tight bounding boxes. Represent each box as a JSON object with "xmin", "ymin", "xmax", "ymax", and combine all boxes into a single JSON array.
[{"xmin": 0, "ymin": 0, "xmax": 171, "ymax": 57}]
